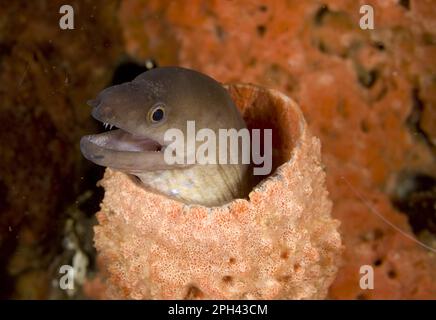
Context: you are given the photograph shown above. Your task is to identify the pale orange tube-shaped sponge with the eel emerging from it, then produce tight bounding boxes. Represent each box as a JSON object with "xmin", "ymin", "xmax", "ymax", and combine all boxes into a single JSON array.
[{"xmin": 95, "ymin": 85, "xmax": 342, "ymax": 299}]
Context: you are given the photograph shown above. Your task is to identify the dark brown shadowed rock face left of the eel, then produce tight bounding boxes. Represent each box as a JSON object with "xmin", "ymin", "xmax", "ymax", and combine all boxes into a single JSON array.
[{"xmin": 0, "ymin": 0, "xmax": 122, "ymax": 299}]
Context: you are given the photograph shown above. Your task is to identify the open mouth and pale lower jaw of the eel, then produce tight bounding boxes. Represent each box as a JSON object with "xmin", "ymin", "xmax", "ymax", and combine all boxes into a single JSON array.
[{"xmin": 80, "ymin": 123, "xmax": 176, "ymax": 174}]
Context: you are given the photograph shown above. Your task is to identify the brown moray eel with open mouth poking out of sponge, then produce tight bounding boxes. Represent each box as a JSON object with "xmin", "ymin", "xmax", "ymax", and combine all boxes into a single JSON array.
[{"xmin": 80, "ymin": 67, "xmax": 251, "ymax": 206}]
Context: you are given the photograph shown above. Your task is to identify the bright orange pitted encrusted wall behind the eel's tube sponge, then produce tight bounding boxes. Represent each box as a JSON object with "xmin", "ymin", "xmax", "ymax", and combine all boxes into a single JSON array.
[{"xmin": 120, "ymin": 0, "xmax": 436, "ymax": 299}]
